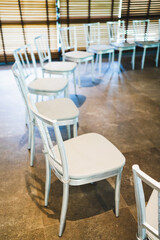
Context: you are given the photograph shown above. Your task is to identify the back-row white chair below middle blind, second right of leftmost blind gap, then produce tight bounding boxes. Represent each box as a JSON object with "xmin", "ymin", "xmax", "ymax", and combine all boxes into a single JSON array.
[{"xmin": 84, "ymin": 22, "xmax": 114, "ymax": 76}]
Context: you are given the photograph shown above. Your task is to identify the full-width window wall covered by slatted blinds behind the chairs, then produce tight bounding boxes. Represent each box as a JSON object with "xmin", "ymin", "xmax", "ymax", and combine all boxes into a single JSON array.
[{"xmin": 0, "ymin": 0, "xmax": 160, "ymax": 63}]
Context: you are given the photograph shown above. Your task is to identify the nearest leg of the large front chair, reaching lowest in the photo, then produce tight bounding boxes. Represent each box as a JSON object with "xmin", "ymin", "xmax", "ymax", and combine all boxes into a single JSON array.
[{"xmin": 59, "ymin": 183, "xmax": 69, "ymax": 237}]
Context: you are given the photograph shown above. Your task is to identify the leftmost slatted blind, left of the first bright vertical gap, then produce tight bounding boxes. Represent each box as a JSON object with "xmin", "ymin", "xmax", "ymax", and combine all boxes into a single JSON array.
[{"xmin": 0, "ymin": 0, "xmax": 57, "ymax": 62}]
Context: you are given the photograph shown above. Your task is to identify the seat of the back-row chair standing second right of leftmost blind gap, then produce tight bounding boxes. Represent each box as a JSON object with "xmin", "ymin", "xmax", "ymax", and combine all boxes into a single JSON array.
[{"xmin": 87, "ymin": 44, "xmax": 114, "ymax": 53}]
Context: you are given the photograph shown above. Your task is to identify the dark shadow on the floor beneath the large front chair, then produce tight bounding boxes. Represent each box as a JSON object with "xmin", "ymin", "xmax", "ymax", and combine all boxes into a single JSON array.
[{"xmin": 25, "ymin": 169, "xmax": 114, "ymax": 221}]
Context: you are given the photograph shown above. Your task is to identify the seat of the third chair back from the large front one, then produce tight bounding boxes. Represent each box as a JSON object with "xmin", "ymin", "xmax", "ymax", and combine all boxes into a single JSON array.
[{"xmin": 28, "ymin": 78, "xmax": 68, "ymax": 93}]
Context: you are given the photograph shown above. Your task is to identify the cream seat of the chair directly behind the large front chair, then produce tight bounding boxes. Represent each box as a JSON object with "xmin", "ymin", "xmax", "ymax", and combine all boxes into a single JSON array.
[{"xmin": 36, "ymin": 98, "xmax": 79, "ymax": 121}]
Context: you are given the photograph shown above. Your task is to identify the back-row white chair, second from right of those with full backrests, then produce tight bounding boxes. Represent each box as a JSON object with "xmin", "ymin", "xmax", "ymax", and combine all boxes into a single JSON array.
[{"xmin": 106, "ymin": 21, "xmax": 136, "ymax": 71}]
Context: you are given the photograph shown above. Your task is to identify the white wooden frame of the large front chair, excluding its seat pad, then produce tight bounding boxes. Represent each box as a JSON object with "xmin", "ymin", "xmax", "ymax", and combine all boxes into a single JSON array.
[{"xmin": 28, "ymin": 95, "xmax": 125, "ymax": 236}]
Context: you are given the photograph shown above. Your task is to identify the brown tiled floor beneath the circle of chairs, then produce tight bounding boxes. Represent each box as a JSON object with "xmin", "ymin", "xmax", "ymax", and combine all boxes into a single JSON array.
[{"xmin": 0, "ymin": 53, "xmax": 160, "ymax": 240}]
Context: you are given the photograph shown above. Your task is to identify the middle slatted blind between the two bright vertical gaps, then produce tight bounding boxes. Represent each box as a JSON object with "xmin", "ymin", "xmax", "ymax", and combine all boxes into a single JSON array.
[{"xmin": 60, "ymin": 0, "xmax": 119, "ymax": 49}]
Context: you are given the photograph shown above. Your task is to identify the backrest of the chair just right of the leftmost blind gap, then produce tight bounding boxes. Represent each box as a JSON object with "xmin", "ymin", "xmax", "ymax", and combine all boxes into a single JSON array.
[{"xmin": 59, "ymin": 26, "xmax": 77, "ymax": 54}]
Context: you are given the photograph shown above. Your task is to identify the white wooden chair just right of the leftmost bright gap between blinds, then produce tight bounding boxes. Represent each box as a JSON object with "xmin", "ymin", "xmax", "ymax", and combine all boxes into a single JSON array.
[{"xmin": 59, "ymin": 26, "xmax": 94, "ymax": 87}]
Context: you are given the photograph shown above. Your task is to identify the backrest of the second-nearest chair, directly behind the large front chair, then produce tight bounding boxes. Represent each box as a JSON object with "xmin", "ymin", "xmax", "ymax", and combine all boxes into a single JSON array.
[{"xmin": 12, "ymin": 62, "xmax": 33, "ymax": 121}]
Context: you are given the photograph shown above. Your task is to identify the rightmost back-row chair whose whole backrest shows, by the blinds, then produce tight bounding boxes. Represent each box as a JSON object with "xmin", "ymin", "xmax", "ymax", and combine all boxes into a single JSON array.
[{"xmin": 133, "ymin": 19, "xmax": 159, "ymax": 69}]
